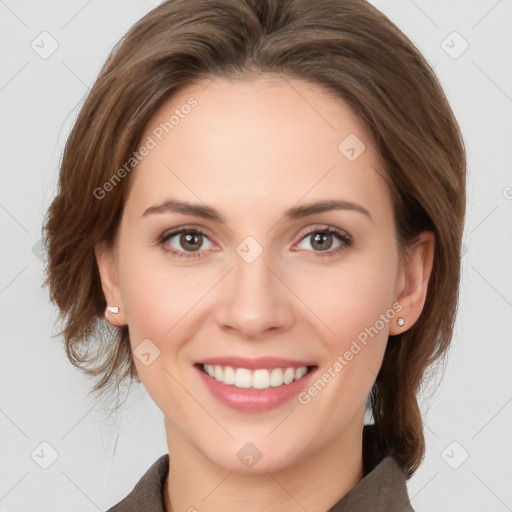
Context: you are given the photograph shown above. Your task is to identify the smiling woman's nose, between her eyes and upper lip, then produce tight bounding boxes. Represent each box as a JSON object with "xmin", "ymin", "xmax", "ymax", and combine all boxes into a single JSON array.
[{"xmin": 216, "ymin": 251, "xmax": 295, "ymax": 340}]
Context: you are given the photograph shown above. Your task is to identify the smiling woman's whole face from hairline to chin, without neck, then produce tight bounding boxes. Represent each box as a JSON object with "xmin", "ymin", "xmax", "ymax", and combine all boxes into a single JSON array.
[{"xmin": 99, "ymin": 78, "xmax": 416, "ymax": 472}]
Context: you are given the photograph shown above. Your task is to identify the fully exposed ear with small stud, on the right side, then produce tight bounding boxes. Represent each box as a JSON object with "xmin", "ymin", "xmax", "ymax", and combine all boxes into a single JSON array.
[{"xmin": 389, "ymin": 231, "xmax": 435, "ymax": 335}]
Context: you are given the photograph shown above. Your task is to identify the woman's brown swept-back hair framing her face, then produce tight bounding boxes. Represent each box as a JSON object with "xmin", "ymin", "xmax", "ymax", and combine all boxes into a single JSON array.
[{"xmin": 44, "ymin": 0, "xmax": 466, "ymax": 477}]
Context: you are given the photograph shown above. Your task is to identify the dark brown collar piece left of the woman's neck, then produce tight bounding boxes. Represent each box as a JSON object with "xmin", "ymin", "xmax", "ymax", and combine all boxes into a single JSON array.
[{"xmin": 106, "ymin": 453, "xmax": 169, "ymax": 512}]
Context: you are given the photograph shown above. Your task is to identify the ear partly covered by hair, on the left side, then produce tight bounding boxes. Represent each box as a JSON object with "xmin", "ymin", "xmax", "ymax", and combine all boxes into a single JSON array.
[{"xmin": 94, "ymin": 243, "xmax": 126, "ymax": 327}]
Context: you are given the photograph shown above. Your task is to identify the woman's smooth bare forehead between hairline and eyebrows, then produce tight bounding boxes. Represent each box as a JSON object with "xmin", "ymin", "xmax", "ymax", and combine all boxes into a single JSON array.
[{"xmin": 124, "ymin": 76, "xmax": 390, "ymax": 224}]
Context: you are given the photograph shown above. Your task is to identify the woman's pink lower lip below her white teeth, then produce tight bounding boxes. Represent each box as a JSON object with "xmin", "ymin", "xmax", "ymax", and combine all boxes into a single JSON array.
[{"xmin": 195, "ymin": 366, "xmax": 316, "ymax": 412}]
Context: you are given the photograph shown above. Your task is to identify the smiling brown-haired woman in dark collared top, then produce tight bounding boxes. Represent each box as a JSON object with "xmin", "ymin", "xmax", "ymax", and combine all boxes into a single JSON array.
[{"xmin": 45, "ymin": 0, "xmax": 465, "ymax": 512}]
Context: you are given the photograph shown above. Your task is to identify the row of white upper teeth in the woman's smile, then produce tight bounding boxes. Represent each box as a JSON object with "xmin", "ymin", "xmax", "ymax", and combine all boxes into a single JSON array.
[{"xmin": 203, "ymin": 364, "xmax": 308, "ymax": 389}]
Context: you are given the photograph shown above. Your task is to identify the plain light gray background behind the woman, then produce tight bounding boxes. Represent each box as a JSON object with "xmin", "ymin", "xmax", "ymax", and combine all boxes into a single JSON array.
[{"xmin": 0, "ymin": 0, "xmax": 512, "ymax": 512}]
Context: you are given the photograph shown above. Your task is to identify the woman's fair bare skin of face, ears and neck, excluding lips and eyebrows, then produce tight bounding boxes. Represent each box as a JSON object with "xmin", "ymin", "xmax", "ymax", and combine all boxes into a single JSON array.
[{"xmin": 96, "ymin": 75, "xmax": 434, "ymax": 512}]
